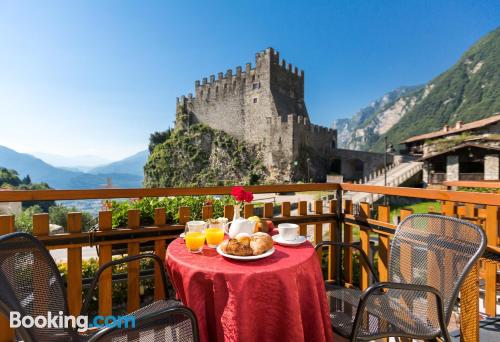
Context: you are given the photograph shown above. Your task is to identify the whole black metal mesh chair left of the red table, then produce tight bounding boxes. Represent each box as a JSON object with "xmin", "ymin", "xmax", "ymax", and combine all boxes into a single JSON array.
[{"xmin": 0, "ymin": 233, "xmax": 198, "ymax": 342}]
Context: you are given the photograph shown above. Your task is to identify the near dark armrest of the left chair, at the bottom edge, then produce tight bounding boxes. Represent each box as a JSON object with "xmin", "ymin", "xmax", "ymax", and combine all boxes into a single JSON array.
[{"xmin": 89, "ymin": 305, "xmax": 199, "ymax": 342}]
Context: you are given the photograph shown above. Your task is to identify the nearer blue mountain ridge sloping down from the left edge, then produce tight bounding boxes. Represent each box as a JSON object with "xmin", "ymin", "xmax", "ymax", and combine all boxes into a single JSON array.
[{"xmin": 0, "ymin": 146, "xmax": 142, "ymax": 189}]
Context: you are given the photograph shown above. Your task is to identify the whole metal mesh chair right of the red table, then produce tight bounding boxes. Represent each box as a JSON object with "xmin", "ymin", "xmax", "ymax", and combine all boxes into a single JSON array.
[{"xmin": 316, "ymin": 214, "xmax": 486, "ymax": 341}]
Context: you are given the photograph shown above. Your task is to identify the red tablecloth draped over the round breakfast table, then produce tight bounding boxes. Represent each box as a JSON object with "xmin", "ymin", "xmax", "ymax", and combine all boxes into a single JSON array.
[{"xmin": 167, "ymin": 239, "xmax": 332, "ymax": 342}]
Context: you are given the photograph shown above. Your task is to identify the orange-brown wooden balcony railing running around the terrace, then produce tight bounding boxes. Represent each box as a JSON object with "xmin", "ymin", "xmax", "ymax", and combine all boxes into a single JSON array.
[{"xmin": 0, "ymin": 183, "xmax": 500, "ymax": 342}]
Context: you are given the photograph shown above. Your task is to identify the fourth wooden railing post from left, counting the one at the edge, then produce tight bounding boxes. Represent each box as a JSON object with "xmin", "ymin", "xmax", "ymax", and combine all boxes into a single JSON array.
[{"xmin": 99, "ymin": 210, "xmax": 113, "ymax": 316}]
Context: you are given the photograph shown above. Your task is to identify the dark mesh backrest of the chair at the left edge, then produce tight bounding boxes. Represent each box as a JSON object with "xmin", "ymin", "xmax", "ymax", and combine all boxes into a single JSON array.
[{"xmin": 0, "ymin": 233, "xmax": 74, "ymax": 341}]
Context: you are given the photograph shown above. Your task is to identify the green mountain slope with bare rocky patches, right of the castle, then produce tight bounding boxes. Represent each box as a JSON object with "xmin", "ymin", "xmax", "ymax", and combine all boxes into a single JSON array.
[{"xmin": 333, "ymin": 28, "xmax": 500, "ymax": 151}]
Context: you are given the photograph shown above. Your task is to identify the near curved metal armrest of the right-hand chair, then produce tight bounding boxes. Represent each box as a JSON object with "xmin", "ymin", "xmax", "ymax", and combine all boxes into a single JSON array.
[{"xmin": 352, "ymin": 282, "xmax": 451, "ymax": 341}]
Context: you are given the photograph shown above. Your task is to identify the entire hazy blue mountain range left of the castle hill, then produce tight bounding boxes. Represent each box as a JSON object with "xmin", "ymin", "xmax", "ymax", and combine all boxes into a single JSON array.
[{"xmin": 0, "ymin": 146, "xmax": 147, "ymax": 189}]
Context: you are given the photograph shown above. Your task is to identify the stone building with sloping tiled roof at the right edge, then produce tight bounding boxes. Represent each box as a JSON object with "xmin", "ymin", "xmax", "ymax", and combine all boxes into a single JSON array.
[{"xmin": 403, "ymin": 113, "xmax": 500, "ymax": 185}]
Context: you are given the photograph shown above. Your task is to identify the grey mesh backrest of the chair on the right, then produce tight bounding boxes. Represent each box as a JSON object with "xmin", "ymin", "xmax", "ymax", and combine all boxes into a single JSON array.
[{"xmin": 389, "ymin": 214, "xmax": 486, "ymax": 322}]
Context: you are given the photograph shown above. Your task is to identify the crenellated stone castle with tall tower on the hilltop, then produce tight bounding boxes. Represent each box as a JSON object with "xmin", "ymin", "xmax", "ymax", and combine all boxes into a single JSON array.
[{"xmin": 176, "ymin": 48, "xmax": 337, "ymax": 181}]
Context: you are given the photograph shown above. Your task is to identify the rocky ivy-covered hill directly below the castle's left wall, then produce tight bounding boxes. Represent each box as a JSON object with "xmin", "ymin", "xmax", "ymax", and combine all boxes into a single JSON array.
[{"xmin": 144, "ymin": 125, "xmax": 267, "ymax": 187}]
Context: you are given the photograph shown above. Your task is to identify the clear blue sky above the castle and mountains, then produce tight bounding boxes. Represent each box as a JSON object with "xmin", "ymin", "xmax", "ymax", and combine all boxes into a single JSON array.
[{"xmin": 0, "ymin": 0, "xmax": 500, "ymax": 160}]
